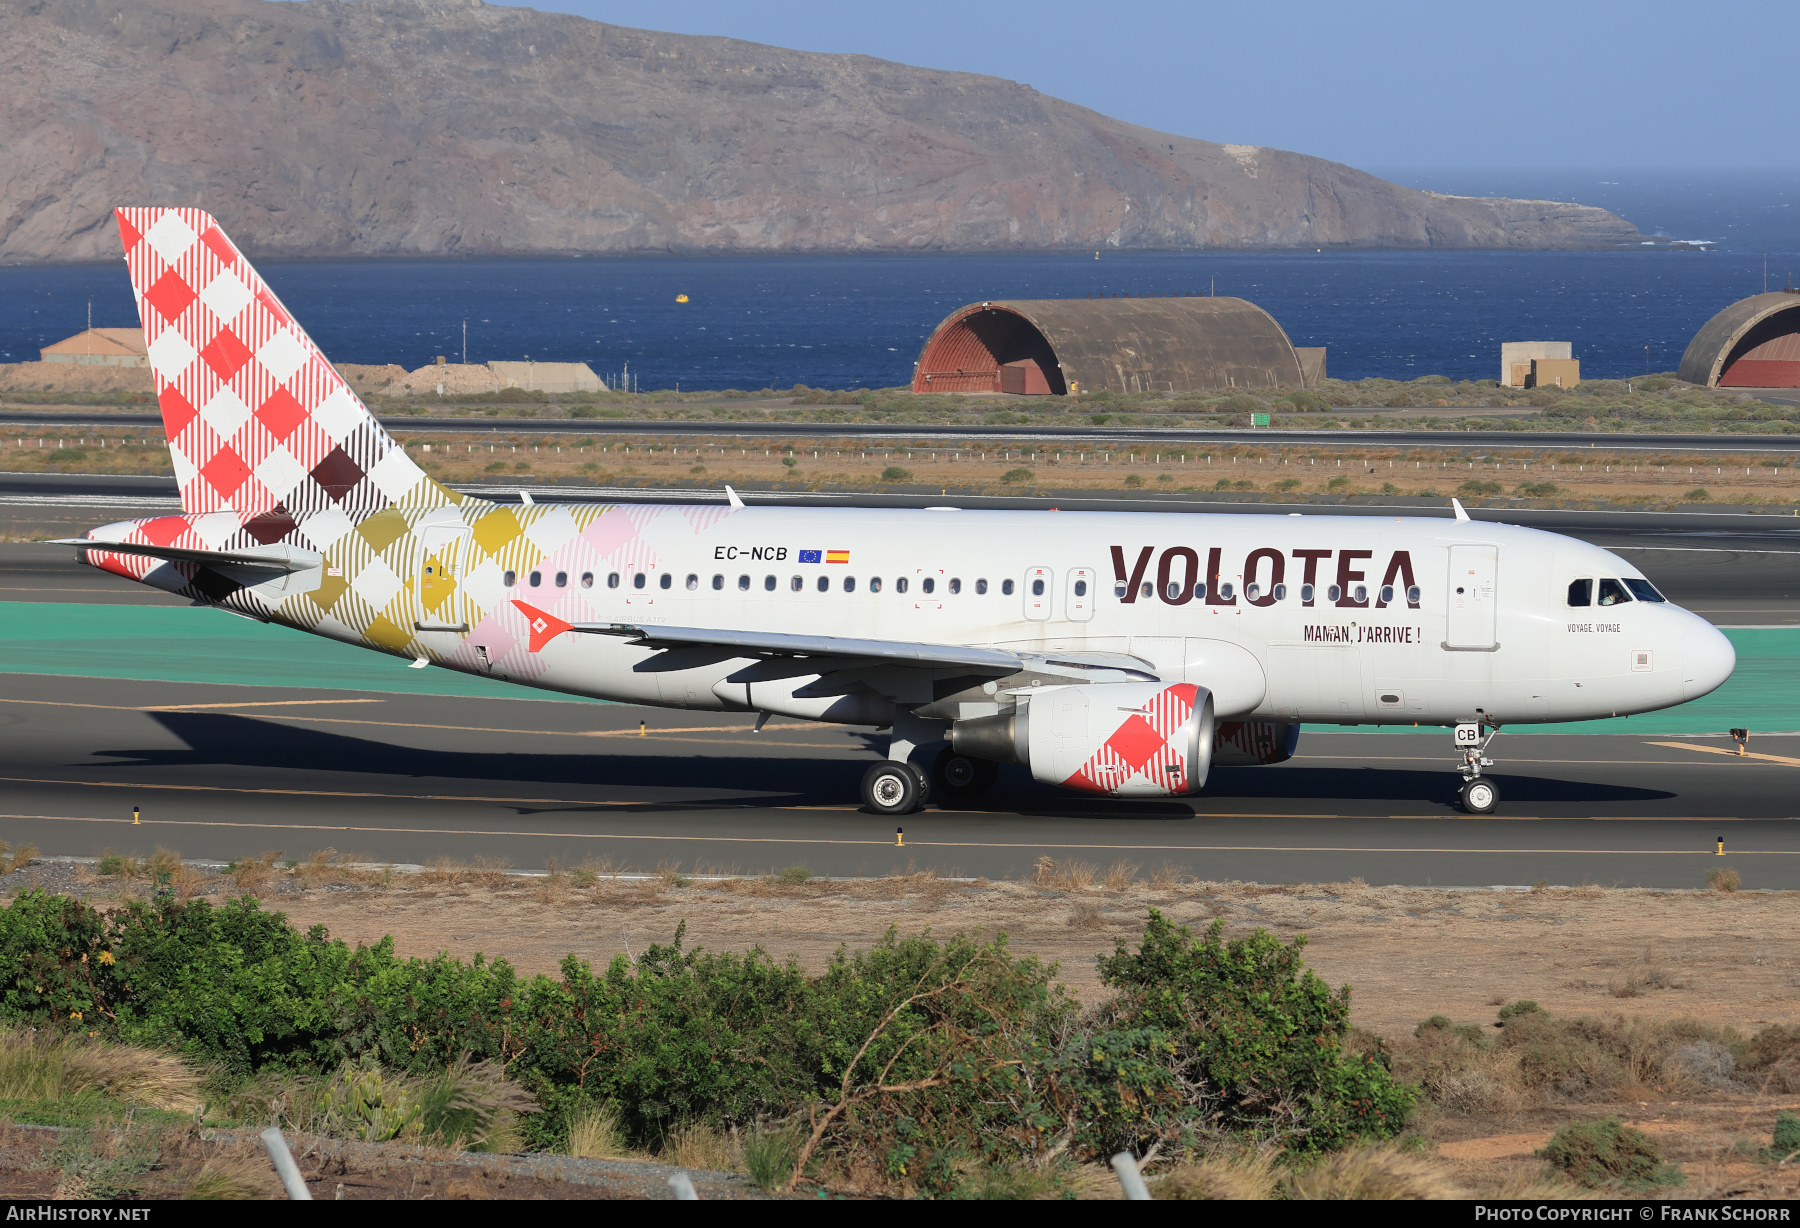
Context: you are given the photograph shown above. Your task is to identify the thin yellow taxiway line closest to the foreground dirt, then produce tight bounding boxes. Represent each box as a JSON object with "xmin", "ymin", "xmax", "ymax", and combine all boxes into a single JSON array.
[{"xmin": 0, "ymin": 814, "xmax": 1800, "ymax": 857}]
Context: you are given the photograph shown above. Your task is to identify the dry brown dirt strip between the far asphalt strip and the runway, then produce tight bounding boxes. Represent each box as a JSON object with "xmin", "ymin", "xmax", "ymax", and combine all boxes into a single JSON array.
[{"xmin": 0, "ymin": 423, "xmax": 1800, "ymax": 506}]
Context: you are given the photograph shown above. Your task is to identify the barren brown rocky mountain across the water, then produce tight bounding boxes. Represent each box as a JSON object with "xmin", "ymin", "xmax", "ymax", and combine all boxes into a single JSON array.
[{"xmin": 0, "ymin": 0, "xmax": 1640, "ymax": 261}]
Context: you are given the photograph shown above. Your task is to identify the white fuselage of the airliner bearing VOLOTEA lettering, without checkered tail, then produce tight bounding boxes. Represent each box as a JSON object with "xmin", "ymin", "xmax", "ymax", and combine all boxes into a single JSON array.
[{"xmin": 421, "ymin": 506, "xmax": 1735, "ymax": 724}]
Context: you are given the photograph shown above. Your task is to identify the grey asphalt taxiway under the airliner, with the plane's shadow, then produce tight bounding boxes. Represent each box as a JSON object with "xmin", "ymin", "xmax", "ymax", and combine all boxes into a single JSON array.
[{"xmin": 0, "ymin": 675, "xmax": 1800, "ymax": 889}]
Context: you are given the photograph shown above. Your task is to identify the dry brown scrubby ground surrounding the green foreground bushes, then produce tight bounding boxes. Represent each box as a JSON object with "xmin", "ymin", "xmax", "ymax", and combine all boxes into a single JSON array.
[{"xmin": 0, "ymin": 850, "xmax": 1800, "ymax": 1199}]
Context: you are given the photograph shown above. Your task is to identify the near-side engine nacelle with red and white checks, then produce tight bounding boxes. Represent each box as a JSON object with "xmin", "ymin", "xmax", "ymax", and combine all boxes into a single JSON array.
[{"xmin": 950, "ymin": 682, "xmax": 1213, "ymax": 798}]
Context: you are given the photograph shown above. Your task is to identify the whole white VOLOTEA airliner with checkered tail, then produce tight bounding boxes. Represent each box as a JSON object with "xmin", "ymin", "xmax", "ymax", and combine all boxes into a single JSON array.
[{"xmin": 68, "ymin": 207, "xmax": 1735, "ymax": 816}]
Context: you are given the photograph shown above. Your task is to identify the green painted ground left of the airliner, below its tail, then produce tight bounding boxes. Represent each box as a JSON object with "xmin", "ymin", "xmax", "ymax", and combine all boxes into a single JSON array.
[{"xmin": 0, "ymin": 601, "xmax": 590, "ymax": 702}]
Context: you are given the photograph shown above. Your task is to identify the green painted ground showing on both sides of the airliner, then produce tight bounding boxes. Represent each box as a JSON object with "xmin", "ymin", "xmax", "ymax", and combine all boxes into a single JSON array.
[{"xmin": 0, "ymin": 601, "xmax": 1800, "ymax": 736}]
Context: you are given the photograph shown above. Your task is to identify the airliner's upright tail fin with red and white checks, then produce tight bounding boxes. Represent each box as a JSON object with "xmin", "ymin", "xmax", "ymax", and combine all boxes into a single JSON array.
[{"xmin": 117, "ymin": 209, "xmax": 463, "ymax": 520}]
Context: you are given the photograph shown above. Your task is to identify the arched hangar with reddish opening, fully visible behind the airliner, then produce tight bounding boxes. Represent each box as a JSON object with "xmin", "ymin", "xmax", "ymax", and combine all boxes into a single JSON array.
[{"xmin": 913, "ymin": 297, "xmax": 1323, "ymax": 396}]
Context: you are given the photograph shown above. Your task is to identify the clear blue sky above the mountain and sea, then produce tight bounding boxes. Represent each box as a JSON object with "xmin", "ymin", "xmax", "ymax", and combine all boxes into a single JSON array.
[{"xmin": 514, "ymin": 0, "xmax": 1800, "ymax": 173}]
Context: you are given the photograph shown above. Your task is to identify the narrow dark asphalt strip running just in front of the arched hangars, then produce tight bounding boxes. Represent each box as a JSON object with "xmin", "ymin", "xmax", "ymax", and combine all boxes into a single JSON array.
[{"xmin": 0, "ymin": 409, "xmax": 1800, "ymax": 456}]
